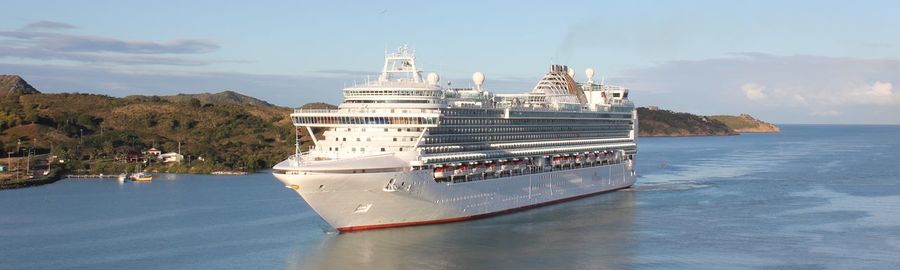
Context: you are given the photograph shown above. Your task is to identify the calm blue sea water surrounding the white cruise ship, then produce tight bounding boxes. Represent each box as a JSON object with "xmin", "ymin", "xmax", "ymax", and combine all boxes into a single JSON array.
[{"xmin": 0, "ymin": 125, "xmax": 900, "ymax": 269}]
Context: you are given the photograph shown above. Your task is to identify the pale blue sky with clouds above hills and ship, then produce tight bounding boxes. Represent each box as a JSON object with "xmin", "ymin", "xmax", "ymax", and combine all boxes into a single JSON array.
[{"xmin": 0, "ymin": 0, "xmax": 900, "ymax": 124}]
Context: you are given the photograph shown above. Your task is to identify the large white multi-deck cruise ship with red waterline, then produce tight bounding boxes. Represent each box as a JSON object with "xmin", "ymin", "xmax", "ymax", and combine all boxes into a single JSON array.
[{"xmin": 273, "ymin": 46, "xmax": 638, "ymax": 232}]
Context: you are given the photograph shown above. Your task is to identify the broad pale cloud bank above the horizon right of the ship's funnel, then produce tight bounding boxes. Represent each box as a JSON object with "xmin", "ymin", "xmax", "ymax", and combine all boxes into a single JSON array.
[{"xmin": 610, "ymin": 52, "xmax": 900, "ymax": 124}]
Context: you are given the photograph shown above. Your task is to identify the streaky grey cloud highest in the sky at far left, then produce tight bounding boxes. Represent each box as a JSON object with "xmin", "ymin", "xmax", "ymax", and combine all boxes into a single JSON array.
[{"xmin": 0, "ymin": 21, "xmax": 223, "ymax": 66}]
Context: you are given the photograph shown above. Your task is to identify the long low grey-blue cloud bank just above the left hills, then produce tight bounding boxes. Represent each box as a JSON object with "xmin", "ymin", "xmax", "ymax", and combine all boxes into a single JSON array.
[{"xmin": 0, "ymin": 62, "xmax": 346, "ymax": 107}]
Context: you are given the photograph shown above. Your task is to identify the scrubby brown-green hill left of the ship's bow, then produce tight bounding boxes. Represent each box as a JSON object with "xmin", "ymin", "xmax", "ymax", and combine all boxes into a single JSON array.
[{"xmin": 0, "ymin": 76, "xmax": 294, "ymax": 173}]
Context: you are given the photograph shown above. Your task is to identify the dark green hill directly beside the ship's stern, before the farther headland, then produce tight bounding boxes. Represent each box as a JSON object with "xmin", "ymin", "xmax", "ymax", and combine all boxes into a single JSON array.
[{"xmin": 637, "ymin": 107, "xmax": 737, "ymax": 136}]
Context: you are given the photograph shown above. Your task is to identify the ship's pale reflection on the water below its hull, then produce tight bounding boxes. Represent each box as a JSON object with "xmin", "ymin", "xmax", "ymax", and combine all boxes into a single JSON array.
[{"xmin": 285, "ymin": 190, "xmax": 637, "ymax": 269}]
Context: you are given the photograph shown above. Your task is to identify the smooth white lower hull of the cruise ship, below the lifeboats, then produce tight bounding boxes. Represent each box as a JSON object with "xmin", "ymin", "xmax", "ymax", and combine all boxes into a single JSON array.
[{"xmin": 275, "ymin": 160, "xmax": 635, "ymax": 232}]
